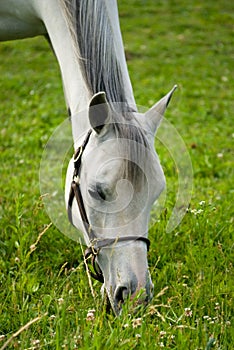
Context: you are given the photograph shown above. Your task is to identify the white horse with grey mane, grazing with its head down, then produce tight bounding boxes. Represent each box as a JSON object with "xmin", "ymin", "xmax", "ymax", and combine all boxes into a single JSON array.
[{"xmin": 0, "ymin": 0, "xmax": 175, "ymax": 313}]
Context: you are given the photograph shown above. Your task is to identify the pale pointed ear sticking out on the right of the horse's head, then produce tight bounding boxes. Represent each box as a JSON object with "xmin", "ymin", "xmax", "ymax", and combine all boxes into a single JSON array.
[{"xmin": 145, "ymin": 85, "xmax": 177, "ymax": 134}]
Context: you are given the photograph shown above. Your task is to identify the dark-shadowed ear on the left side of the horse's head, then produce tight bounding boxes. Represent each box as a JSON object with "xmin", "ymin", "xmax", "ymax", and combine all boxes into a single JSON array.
[{"xmin": 89, "ymin": 92, "xmax": 110, "ymax": 134}]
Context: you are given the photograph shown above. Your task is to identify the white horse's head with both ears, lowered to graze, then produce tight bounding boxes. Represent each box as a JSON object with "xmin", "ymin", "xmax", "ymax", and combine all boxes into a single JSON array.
[{"xmin": 66, "ymin": 88, "xmax": 175, "ymax": 314}]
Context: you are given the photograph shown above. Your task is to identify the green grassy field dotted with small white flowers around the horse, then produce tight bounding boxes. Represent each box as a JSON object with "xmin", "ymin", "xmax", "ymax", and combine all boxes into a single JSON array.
[{"xmin": 0, "ymin": 0, "xmax": 234, "ymax": 350}]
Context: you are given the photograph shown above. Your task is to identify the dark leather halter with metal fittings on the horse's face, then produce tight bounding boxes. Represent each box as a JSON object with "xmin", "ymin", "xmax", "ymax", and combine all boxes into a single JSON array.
[{"xmin": 67, "ymin": 129, "xmax": 150, "ymax": 283}]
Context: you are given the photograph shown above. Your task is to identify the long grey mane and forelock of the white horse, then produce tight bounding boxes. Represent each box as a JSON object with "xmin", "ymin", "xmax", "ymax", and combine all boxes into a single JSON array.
[{"xmin": 60, "ymin": 0, "xmax": 149, "ymax": 182}]
